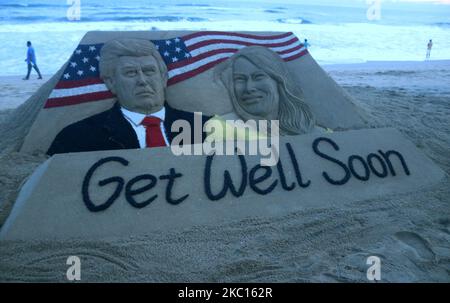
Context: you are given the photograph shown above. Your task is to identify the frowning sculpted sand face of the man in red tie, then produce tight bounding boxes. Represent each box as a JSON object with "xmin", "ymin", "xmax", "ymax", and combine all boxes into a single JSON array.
[{"xmin": 107, "ymin": 56, "xmax": 165, "ymax": 114}]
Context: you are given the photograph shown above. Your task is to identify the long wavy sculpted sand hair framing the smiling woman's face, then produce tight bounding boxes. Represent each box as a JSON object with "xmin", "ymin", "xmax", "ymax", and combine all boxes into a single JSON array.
[{"xmin": 214, "ymin": 46, "xmax": 315, "ymax": 135}]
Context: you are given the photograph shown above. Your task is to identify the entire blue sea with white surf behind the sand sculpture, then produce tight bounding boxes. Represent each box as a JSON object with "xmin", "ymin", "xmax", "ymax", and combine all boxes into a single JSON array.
[{"xmin": 0, "ymin": 0, "xmax": 450, "ymax": 76}]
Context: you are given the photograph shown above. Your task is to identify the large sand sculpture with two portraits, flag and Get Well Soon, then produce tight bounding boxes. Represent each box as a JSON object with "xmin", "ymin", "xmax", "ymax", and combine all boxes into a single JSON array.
[{"xmin": 0, "ymin": 32, "xmax": 444, "ymax": 239}]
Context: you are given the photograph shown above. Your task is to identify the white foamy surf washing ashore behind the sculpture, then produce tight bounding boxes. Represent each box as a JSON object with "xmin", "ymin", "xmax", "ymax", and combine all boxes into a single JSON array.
[{"xmin": 0, "ymin": 20, "xmax": 450, "ymax": 75}]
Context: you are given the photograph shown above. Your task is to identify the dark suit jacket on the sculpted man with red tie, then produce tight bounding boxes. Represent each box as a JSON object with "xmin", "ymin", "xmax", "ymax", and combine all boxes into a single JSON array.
[{"xmin": 47, "ymin": 102, "xmax": 211, "ymax": 156}]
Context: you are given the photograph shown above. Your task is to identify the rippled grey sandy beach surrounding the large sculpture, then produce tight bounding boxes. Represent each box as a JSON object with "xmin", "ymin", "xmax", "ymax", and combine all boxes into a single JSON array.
[{"xmin": 0, "ymin": 60, "xmax": 450, "ymax": 282}]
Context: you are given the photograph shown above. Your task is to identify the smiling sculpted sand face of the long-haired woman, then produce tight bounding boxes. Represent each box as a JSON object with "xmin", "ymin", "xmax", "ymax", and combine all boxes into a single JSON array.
[{"xmin": 233, "ymin": 57, "xmax": 279, "ymax": 120}]
